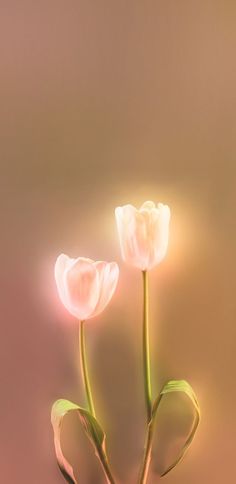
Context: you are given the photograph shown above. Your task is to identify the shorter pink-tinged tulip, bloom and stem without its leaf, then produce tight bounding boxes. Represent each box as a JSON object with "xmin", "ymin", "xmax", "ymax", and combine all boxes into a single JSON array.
[{"xmin": 55, "ymin": 254, "xmax": 119, "ymax": 484}]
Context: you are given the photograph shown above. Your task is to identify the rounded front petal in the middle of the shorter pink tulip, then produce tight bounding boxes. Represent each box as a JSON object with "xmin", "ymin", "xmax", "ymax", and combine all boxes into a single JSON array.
[{"xmin": 64, "ymin": 257, "xmax": 99, "ymax": 320}]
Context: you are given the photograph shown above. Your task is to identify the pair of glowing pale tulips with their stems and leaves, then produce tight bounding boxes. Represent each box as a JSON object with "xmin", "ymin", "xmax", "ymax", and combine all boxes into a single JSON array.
[{"xmin": 52, "ymin": 201, "xmax": 200, "ymax": 484}]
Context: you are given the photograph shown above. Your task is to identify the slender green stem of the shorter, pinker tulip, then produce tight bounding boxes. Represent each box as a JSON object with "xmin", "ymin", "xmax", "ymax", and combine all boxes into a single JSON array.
[{"xmin": 79, "ymin": 321, "xmax": 115, "ymax": 484}]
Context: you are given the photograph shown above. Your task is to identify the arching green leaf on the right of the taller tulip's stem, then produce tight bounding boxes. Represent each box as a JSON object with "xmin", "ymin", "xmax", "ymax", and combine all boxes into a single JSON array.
[{"xmin": 152, "ymin": 380, "xmax": 200, "ymax": 477}]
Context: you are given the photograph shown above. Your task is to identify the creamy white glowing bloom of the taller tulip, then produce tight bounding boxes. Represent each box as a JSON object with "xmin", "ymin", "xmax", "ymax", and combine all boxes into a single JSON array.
[{"xmin": 115, "ymin": 201, "xmax": 170, "ymax": 271}]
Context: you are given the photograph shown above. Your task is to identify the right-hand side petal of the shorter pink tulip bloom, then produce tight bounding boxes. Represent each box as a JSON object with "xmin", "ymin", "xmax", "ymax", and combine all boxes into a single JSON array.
[{"xmin": 92, "ymin": 261, "xmax": 119, "ymax": 317}]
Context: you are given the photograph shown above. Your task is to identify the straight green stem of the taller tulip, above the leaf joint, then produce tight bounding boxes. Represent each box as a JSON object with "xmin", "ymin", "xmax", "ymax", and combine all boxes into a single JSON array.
[{"xmin": 143, "ymin": 271, "xmax": 152, "ymax": 424}]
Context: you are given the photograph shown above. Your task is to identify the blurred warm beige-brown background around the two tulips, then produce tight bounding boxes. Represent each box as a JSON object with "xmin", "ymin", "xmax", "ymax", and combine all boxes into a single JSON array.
[{"xmin": 0, "ymin": 0, "xmax": 236, "ymax": 484}]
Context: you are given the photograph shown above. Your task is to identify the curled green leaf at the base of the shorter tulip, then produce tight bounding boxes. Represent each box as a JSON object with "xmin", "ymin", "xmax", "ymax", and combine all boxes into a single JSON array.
[{"xmin": 51, "ymin": 399, "xmax": 109, "ymax": 484}]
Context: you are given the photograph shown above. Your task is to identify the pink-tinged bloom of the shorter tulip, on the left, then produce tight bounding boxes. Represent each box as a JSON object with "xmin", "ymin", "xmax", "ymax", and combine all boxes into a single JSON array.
[{"xmin": 55, "ymin": 254, "xmax": 119, "ymax": 321}]
